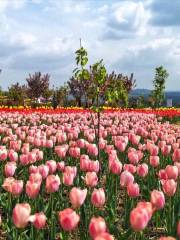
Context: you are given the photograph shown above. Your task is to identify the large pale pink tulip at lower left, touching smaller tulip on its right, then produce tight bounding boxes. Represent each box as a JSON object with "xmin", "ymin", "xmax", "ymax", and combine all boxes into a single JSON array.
[{"xmin": 12, "ymin": 203, "xmax": 31, "ymax": 228}]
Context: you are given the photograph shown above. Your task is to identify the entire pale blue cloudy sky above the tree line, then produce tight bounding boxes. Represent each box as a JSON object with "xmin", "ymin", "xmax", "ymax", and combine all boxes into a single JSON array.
[{"xmin": 0, "ymin": 0, "xmax": 180, "ymax": 90}]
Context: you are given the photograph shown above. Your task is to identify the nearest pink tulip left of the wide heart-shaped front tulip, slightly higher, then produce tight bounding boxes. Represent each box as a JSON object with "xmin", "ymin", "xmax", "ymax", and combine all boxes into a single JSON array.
[{"xmin": 46, "ymin": 175, "xmax": 60, "ymax": 193}]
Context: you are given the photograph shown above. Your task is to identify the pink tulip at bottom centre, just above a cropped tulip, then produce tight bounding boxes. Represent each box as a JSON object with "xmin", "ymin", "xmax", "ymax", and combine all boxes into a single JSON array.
[{"xmin": 89, "ymin": 217, "xmax": 107, "ymax": 239}]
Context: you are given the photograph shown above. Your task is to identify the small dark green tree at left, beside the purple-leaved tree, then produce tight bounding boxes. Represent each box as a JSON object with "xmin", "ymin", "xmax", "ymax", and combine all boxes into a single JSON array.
[{"xmin": 8, "ymin": 82, "xmax": 26, "ymax": 105}]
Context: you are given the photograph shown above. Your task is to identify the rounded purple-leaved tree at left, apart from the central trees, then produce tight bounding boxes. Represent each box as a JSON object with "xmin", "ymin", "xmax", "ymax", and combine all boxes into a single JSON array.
[{"xmin": 26, "ymin": 72, "xmax": 50, "ymax": 99}]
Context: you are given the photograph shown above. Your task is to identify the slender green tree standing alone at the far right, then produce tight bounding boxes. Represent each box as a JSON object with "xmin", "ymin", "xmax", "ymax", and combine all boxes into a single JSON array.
[{"xmin": 152, "ymin": 66, "xmax": 169, "ymax": 107}]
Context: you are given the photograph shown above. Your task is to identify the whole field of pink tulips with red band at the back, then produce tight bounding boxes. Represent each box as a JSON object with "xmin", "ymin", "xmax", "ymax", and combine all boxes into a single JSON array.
[{"xmin": 0, "ymin": 109, "xmax": 180, "ymax": 240}]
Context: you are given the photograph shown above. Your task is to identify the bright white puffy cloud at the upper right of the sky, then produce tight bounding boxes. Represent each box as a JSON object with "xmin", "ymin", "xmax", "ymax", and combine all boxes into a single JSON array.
[{"xmin": 104, "ymin": 0, "xmax": 151, "ymax": 40}]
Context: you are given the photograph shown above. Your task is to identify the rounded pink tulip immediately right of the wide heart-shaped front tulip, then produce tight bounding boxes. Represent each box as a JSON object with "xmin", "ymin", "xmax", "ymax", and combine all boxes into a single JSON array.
[{"xmin": 91, "ymin": 188, "xmax": 106, "ymax": 208}]
